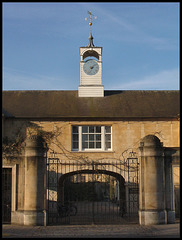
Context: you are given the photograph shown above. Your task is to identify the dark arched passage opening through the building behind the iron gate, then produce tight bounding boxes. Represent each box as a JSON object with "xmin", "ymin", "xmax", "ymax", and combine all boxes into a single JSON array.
[{"xmin": 58, "ymin": 169, "xmax": 126, "ymax": 224}]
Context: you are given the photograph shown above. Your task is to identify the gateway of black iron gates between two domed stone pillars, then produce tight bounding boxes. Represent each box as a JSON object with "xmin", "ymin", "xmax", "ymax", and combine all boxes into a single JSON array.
[{"xmin": 8, "ymin": 135, "xmax": 175, "ymax": 225}]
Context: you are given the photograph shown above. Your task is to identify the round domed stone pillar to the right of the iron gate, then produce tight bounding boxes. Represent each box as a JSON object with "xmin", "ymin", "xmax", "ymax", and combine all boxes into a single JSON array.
[{"xmin": 139, "ymin": 135, "xmax": 167, "ymax": 225}]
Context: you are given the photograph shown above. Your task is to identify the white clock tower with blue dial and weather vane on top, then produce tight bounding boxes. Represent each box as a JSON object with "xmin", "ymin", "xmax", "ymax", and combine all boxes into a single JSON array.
[{"xmin": 78, "ymin": 12, "xmax": 104, "ymax": 97}]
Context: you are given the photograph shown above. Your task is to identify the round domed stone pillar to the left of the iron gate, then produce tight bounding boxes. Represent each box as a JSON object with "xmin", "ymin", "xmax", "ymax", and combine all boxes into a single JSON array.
[{"xmin": 23, "ymin": 136, "xmax": 46, "ymax": 225}]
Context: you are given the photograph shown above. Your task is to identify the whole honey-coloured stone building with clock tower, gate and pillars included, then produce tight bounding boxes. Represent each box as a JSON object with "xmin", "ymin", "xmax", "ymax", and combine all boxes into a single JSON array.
[{"xmin": 2, "ymin": 31, "xmax": 179, "ymax": 225}]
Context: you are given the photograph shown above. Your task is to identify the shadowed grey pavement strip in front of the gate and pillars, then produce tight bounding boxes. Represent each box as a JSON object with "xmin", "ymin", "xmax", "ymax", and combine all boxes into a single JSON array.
[{"xmin": 2, "ymin": 223, "xmax": 180, "ymax": 238}]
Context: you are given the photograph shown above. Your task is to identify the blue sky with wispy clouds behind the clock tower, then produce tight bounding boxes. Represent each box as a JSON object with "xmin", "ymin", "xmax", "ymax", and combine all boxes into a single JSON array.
[{"xmin": 2, "ymin": 2, "xmax": 179, "ymax": 90}]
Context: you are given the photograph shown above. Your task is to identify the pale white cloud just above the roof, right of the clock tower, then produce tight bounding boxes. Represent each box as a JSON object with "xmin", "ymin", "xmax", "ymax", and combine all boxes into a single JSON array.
[{"xmin": 108, "ymin": 69, "xmax": 179, "ymax": 90}]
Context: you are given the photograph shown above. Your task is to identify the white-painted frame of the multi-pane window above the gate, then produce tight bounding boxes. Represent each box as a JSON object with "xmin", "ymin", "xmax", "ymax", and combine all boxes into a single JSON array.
[{"xmin": 71, "ymin": 125, "xmax": 112, "ymax": 152}]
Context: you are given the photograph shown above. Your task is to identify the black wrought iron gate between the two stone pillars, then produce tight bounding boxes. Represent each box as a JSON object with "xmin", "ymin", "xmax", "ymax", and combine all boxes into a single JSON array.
[{"xmin": 47, "ymin": 153, "xmax": 138, "ymax": 224}]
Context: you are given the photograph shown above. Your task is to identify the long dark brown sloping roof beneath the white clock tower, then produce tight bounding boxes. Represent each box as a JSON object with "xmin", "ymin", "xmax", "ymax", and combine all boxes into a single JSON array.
[{"xmin": 2, "ymin": 91, "xmax": 180, "ymax": 119}]
